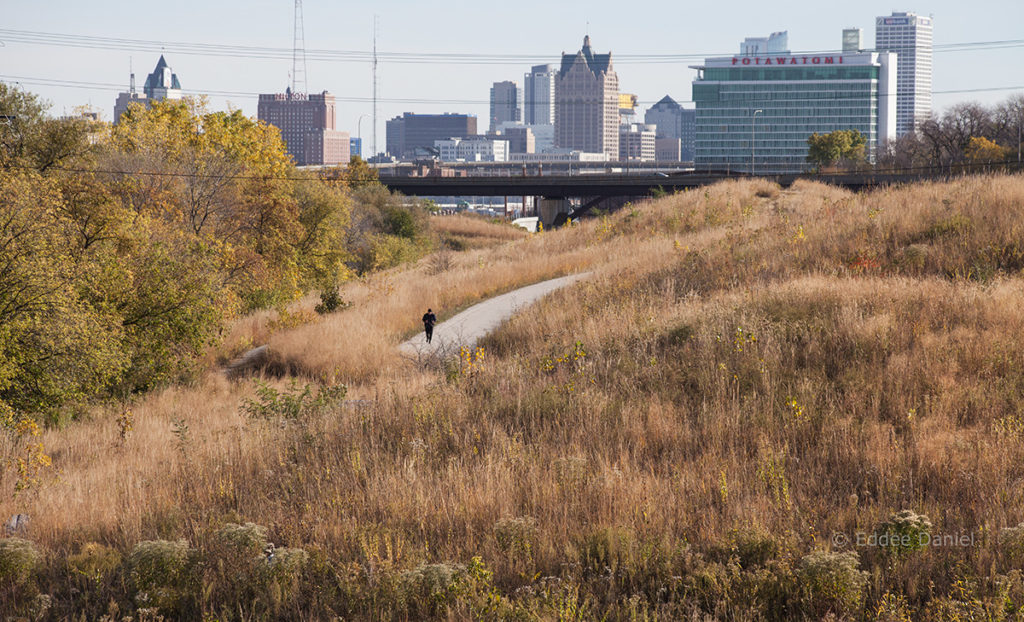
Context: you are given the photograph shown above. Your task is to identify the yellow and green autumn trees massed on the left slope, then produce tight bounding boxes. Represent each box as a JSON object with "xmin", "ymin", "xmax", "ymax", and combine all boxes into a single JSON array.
[{"xmin": 0, "ymin": 83, "xmax": 430, "ymax": 421}]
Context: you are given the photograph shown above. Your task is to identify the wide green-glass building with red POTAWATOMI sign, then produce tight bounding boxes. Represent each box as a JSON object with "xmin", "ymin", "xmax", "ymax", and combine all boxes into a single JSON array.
[{"xmin": 693, "ymin": 39, "xmax": 897, "ymax": 173}]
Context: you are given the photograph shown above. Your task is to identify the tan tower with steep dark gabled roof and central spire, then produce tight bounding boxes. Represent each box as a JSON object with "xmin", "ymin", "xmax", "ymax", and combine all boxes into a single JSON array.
[{"xmin": 555, "ymin": 35, "xmax": 618, "ymax": 160}]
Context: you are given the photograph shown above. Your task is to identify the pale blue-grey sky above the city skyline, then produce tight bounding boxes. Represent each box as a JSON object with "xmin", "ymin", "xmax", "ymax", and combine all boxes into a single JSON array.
[{"xmin": 0, "ymin": 0, "xmax": 1024, "ymax": 154}]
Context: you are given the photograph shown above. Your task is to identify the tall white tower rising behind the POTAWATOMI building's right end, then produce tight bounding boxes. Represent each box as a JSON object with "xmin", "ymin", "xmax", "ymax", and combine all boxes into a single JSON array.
[{"xmin": 874, "ymin": 11, "xmax": 932, "ymax": 136}]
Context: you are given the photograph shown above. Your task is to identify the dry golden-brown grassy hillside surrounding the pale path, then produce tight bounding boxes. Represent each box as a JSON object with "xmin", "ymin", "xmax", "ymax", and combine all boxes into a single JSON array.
[{"xmin": 6, "ymin": 176, "xmax": 1024, "ymax": 620}]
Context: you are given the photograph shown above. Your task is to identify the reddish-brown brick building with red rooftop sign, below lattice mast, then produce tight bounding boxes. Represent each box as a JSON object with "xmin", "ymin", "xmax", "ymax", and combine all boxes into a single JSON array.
[{"xmin": 256, "ymin": 88, "xmax": 350, "ymax": 166}]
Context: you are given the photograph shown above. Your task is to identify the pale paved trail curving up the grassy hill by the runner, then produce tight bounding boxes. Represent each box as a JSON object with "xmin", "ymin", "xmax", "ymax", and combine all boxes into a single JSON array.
[{"xmin": 398, "ymin": 273, "xmax": 591, "ymax": 357}]
